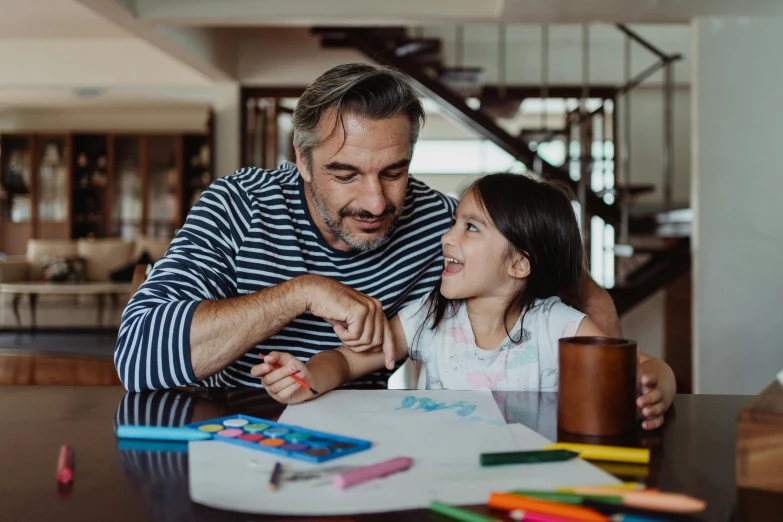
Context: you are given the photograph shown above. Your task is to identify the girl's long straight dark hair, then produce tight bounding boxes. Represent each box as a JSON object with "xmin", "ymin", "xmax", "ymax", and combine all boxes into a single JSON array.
[{"xmin": 414, "ymin": 174, "xmax": 583, "ymax": 344}]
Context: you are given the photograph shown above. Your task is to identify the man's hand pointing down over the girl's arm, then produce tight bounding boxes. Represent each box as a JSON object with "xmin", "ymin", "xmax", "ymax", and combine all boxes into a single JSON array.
[{"xmin": 301, "ymin": 274, "xmax": 394, "ymax": 367}]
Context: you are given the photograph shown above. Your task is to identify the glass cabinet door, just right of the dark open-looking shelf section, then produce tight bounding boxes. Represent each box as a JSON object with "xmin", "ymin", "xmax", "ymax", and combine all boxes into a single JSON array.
[{"xmin": 112, "ymin": 136, "xmax": 142, "ymax": 240}]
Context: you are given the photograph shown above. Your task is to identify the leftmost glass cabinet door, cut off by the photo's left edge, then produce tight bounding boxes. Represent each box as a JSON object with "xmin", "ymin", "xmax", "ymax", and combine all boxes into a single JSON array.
[{"xmin": 0, "ymin": 135, "xmax": 33, "ymax": 223}]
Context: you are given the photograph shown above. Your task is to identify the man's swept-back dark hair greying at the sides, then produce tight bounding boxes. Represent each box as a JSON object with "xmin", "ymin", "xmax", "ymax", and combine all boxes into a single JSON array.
[{"xmin": 294, "ymin": 63, "xmax": 424, "ymax": 169}]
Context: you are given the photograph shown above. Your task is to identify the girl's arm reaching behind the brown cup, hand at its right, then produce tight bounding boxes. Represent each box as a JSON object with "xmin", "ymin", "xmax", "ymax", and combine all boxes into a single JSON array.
[{"xmin": 576, "ymin": 317, "xmax": 677, "ymax": 430}]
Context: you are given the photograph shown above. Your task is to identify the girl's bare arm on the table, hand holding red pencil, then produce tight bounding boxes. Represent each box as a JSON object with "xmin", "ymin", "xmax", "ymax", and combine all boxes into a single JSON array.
[{"xmin": 250, "ymin": 316, "xmax": 408, "ymax": 404}]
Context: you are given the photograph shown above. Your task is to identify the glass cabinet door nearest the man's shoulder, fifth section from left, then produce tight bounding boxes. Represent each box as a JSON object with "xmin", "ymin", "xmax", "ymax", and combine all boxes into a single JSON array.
[{"xmin": 145, "ymin": 135, "xmax": 180, "ymax": 238}]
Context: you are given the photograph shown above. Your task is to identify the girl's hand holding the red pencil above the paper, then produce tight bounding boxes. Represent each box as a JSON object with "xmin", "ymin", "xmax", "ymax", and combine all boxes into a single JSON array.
[{"xmin": 250, "ymin": 352, "xmax": 314, "ymax": 404}]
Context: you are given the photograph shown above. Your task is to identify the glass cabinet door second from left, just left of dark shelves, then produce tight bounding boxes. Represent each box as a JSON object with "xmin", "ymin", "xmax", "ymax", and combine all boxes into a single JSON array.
[{"xmin": 38, "ymin": 136, "xmax": 68, "ymax": 224}]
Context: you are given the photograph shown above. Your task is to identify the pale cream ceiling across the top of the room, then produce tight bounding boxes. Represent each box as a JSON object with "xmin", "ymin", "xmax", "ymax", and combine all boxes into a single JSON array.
[{"xmin": 0, "ymin": 0, "xmax": 772, "ymax": 108}]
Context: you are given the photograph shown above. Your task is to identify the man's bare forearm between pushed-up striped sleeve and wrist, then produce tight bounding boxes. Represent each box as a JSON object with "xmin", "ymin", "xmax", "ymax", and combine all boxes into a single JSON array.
[{"xmin": 190, "ymin": 278, "xmax": 306, "ymax": 379}]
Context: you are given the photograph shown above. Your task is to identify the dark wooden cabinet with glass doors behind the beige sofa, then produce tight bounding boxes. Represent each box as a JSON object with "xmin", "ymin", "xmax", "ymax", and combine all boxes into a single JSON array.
[{"xmin": 0, "ymin": 132, "xmax": 214, "ymax": 255}]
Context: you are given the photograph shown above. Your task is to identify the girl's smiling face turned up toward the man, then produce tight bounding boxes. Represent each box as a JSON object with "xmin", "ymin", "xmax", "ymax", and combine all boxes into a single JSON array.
[{"xmin": 440, "ymin": 190, "xmax": 529, "ymax": 300}]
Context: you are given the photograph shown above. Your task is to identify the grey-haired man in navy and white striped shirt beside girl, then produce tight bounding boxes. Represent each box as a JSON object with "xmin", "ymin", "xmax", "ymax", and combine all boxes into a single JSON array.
[{"xmin": 114, "ymin": 64, "xmax": 619, "ymax": 391}]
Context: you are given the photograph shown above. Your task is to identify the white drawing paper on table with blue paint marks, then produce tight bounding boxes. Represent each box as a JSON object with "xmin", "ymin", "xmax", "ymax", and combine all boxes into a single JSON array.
[{"xmin": 189, "ymin": 390, "xmax": 618, "ymax": 516}]
